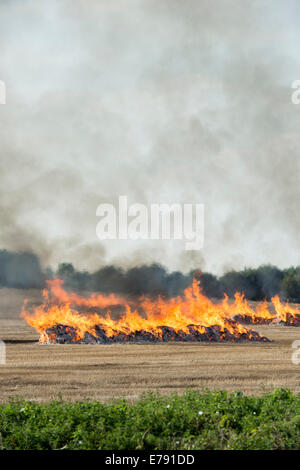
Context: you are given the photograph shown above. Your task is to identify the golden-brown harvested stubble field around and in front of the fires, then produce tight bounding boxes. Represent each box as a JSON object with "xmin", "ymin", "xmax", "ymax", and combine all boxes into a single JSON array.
[{"xmin": 0, "ymin": 289, "xmax": 300, "ymax": 402}]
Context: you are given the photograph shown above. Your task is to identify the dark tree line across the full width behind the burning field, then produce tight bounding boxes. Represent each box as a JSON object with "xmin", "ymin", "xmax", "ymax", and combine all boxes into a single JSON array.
[{"xmin": 0, "ymin": 250, "xmax": 300, "ymax": 302}]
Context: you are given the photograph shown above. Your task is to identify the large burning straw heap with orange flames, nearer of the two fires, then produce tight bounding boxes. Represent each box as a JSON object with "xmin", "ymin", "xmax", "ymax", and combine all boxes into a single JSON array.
[{"xmin": 21, "ymin": 279, "xmax": 267, "ymax": 343}]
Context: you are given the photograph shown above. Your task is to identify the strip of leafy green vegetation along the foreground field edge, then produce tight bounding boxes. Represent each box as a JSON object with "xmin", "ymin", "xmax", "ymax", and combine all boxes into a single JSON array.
[{"xmin": 0, "ymin": 389, "xmax": 300, "ymax": 450}]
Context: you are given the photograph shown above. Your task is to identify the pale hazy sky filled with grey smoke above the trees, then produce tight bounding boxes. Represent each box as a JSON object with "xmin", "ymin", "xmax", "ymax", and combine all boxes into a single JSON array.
[{"xmin": 0, "ymin": 0, "xmax": 300, "ymax": 273}]
